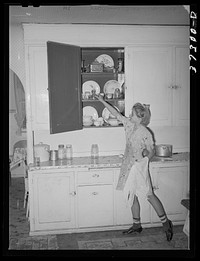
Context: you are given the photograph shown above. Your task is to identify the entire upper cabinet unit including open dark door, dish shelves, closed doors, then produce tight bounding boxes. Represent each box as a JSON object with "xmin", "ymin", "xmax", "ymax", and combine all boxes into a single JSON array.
[{"xmin": 23, "ymin": 24, "xmax": 189, "ymax": 133}]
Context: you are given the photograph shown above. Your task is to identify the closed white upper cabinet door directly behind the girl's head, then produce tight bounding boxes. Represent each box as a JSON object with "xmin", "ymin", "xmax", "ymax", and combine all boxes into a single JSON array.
[{"xmin": 126, "ymin": 46, "xmax": 173, "ymax": 126}]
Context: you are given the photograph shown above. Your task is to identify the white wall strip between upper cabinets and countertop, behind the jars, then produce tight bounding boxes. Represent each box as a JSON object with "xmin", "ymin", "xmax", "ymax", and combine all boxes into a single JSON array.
[{"xmin": 34, "ymin": 126, "xmax": 190, "ymax": 157}]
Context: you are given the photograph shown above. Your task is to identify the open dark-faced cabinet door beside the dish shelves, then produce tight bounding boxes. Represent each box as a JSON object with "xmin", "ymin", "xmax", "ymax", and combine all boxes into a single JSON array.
[{"xmin": 47, "ymin": 42, "xmax": 83, "ymax": 134}]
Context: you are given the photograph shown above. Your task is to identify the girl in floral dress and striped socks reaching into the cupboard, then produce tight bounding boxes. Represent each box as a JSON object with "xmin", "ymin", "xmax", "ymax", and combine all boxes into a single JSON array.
[{"xmin": 96, "ymin": 95, "xmax": 173, "ymax": 241}]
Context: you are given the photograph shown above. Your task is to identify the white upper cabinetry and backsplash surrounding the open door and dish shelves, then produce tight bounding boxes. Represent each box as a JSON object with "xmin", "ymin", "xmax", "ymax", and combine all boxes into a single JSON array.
[{"xmin": 23, "ymin": 24, "xmax": 189, "ymax": 163}]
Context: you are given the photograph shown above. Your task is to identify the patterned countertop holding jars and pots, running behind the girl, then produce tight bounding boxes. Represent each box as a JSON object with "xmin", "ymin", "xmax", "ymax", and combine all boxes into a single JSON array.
[{"xmin": 29, "ymin": 152, "xmax": 189, "ymax": 171}]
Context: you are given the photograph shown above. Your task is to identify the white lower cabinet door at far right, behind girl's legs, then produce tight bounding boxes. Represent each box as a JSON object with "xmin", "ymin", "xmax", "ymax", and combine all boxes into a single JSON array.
[{"xmin": 151, "ymin": 166, "xmax": 189, "ymax": 223}]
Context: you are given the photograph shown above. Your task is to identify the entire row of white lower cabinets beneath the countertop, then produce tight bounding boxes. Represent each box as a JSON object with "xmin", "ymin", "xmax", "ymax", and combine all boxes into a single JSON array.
[{"xmin": 29, "ymin": 163, "xmax": 189, "ymax": 235}]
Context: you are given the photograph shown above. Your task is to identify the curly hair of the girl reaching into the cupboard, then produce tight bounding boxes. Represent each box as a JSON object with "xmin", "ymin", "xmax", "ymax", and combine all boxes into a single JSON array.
[{"xmin": 132, "ymin": 102, "xmax": 151, "ymax": 126}]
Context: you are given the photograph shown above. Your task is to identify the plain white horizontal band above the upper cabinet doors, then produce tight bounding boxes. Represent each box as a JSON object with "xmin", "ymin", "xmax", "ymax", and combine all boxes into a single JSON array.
[{"xmin": 23, "ymin": 24, "xmax": 190, "ymax": 46}]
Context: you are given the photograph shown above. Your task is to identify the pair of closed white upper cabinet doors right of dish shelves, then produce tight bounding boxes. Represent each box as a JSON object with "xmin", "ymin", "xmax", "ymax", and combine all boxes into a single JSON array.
[{"xmin": 126, "ymin": 45, "xmax": 189, "ymax": 126}]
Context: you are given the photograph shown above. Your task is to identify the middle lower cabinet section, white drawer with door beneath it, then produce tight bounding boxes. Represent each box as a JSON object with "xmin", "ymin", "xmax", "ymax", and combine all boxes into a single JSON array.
[{"xmin": 77, "ymin": 169, "xmax": 114, "ymax": 228}]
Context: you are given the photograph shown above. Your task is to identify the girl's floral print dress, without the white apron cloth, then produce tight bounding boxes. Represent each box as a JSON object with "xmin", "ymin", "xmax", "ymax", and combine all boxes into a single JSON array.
[{"xmin": 116, "ymin": 115, "xmax": 154, "ymax": 190}]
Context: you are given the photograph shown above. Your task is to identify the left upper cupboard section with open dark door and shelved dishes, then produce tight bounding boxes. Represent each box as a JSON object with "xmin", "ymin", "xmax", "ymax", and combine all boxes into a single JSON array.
[{"xmin": 28, "ymin": 41, "xmax": 125, "ymax": 134}]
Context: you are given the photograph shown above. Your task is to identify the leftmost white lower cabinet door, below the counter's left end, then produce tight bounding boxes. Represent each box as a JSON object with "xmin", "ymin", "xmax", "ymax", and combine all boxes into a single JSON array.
[{"xmin": 29, "ymin": 172, "xmax": 75, "ymax": 231}]
